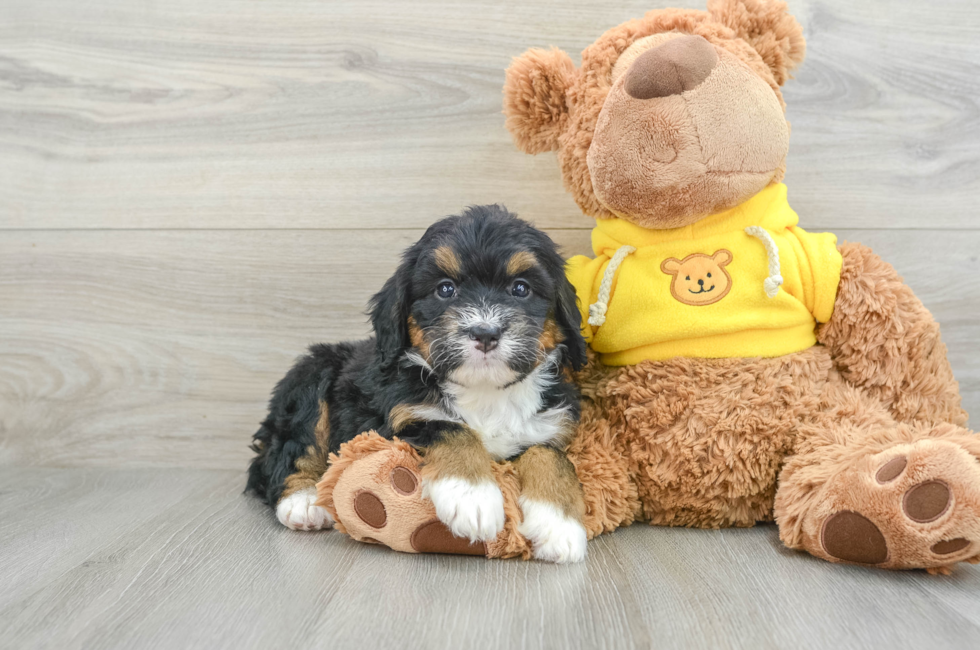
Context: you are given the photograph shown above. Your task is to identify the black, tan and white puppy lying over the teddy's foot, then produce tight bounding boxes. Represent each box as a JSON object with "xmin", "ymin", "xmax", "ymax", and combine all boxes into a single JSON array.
[{"xmin": 248, "ymin": 206, "xmax": 586, "ymax": 562}]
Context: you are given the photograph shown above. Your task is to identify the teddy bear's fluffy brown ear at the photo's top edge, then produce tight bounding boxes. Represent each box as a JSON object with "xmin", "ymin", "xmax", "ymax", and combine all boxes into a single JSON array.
[{"xmin": 708, "ymin": 0, "xmax": 806, "ymax": 86}]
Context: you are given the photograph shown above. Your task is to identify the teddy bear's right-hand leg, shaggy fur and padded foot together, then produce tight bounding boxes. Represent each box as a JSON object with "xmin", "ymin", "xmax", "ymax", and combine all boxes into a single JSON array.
[{"xmin": 775, "ymin": 372, "xmax": 980, "ymax": 572}]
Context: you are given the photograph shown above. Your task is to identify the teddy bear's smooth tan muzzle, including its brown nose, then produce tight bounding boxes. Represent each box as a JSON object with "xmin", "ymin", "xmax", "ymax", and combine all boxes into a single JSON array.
[{"xmin": 586, "ymin": 35, "xmax": 789, "ymax": 229}]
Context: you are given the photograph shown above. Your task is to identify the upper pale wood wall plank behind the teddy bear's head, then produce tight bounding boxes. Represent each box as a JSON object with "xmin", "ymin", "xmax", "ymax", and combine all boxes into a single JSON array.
[{"xmin": 0, "ymin": 0, "xmax": 980, "ymax": 229}]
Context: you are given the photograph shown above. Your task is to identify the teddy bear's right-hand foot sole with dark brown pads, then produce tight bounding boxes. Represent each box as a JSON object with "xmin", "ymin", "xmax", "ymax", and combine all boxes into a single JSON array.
[{"xmin": 815, "ymin": 440, "xmax": 980, "ymax": 569}]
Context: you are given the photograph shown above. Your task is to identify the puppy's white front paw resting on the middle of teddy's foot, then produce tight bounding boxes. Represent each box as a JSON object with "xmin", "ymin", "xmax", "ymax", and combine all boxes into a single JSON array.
[{"xmin": 422, "ymin": 476, "xmax": 504, "ymax": 542}]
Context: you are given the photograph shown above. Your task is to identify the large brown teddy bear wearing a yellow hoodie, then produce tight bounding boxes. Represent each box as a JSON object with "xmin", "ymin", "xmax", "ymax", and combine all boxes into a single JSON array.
[{"xmin": 319, "ymin": 0, "xmax": 980, "ymax": 572}]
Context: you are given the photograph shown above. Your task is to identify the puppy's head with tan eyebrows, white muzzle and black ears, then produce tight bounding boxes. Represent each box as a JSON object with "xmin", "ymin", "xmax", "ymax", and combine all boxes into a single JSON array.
[{"xmin": 375, "ymin": 206, "xmax": 585, "ymax": 387}]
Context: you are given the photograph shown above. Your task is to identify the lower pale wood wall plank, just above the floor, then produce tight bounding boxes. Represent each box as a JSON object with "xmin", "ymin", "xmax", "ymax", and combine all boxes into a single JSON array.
[{"xmin": 0, "ymin": 230, "xmax": 980, "ymax": 469}]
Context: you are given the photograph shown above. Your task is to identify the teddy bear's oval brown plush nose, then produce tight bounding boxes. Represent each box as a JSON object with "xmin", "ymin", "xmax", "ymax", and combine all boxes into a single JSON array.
[{"xmin": 625, "ymin": 36, "xmax": 718, "ymax": 99}]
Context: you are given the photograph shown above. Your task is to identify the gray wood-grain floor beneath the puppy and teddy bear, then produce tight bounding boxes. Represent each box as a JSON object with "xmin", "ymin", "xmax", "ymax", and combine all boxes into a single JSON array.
[{"xmin": 0, "ymin": 469, "xmax": 980, "ymax": 650}]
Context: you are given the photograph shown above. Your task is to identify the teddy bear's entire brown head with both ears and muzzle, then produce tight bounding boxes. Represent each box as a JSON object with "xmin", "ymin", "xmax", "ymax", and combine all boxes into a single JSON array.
[{"xmin": 504, "ymin": 0, "xmax": 806, "ymax": 228}]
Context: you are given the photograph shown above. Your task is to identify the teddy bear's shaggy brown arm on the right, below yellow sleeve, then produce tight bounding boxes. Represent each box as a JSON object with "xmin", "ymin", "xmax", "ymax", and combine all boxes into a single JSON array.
[{"xmin": 817, "ymin": 243, "xmax": 966, "ymax": 426}]
